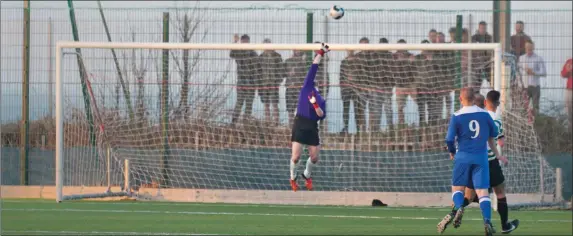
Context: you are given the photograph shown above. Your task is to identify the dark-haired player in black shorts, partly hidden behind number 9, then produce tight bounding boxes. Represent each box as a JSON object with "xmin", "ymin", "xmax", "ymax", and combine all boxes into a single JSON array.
[{"xmin": 456, "ymin": 90, "xmax": 519, "ymax": 234}]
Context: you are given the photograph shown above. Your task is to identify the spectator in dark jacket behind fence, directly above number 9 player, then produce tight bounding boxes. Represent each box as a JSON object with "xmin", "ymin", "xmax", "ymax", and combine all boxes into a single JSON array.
[{"xmin": 471, "ymin": 21, "xmax": 493, "ymax": 90}]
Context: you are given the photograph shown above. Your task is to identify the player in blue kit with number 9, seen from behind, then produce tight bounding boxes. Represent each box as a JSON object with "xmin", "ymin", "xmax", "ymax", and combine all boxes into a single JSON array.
[{"xmin": 438, "ymin": 88, "xmax": 500, "ymax": 235}]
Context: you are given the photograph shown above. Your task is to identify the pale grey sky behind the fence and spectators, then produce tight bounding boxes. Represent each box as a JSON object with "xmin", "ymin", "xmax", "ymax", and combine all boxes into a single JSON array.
[{"xmin": 0, "ymin": 1, "xmax": 572, "ymax": 131}]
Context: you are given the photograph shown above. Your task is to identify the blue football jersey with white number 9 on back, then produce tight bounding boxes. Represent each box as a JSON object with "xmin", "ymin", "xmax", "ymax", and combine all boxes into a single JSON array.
[{"xmin": 446, "ymin": 106, "xmax": 498, "ymax": 164}]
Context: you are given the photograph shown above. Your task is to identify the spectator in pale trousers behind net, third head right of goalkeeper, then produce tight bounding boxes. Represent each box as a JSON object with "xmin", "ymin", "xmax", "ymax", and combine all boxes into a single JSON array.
[{"xmin": 392, "ymin": 39, "xmax": 416, "ymax": 124}]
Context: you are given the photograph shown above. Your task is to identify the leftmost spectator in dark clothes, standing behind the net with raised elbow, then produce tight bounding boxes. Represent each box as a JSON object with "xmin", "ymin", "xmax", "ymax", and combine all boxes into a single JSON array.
[{"xmin": 230, "ymin": 34, "xmax": 262, "ymax": 124}]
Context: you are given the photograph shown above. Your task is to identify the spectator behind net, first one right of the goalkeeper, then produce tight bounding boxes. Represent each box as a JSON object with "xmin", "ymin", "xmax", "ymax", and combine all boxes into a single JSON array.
[{"xmin": 340, "ymin": 51, "xmax": 358, "ymax": 132}]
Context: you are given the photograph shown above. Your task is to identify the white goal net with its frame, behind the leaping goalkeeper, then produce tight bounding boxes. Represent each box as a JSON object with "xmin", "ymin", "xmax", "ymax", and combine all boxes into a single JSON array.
[{"xmin": 56, "ymin": 42, "xmax": 556, "ymax": 206}]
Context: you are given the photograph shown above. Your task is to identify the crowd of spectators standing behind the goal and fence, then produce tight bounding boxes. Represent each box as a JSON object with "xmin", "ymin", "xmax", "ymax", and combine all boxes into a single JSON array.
[{"xmin": 230, "ymin": 21, "xmax": 573, "ymax": 132}]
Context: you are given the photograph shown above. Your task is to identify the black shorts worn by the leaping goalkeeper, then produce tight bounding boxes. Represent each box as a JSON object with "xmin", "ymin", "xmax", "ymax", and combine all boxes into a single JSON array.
[{"xmin": 290, "ymin": 116, "xmax": 320, "ymax": 146}]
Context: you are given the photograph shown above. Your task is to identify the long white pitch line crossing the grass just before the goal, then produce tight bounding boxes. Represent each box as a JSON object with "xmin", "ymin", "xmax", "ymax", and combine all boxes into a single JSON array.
[{"xmin": 3, "ymin": 208, "xmax": 573, "ymax": 223}]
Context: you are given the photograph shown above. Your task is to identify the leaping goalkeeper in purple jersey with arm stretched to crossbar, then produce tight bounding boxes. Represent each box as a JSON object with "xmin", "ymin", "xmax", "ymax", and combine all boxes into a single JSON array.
[{"xmin": 290, "ymin": 43, "xmax": 329, "ymax": 192}]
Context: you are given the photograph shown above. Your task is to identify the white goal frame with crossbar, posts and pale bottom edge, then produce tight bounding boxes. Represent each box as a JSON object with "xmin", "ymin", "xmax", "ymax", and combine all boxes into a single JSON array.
[{"xmin": 55, "ymin": 41, "xmax": 549, "ymax": 206}]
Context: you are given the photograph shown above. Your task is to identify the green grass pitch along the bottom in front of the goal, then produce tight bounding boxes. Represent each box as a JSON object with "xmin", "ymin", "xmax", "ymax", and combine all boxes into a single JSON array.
[{"xmin": 1, "ymin": 200, "xmax": 573, "ymax": 235}]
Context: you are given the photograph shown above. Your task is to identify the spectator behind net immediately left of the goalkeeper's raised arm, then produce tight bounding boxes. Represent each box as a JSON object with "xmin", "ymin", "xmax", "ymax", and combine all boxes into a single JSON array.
[{"xmin": 285, "ymin": 50, "xmax": 307, "ymax": 125}]
